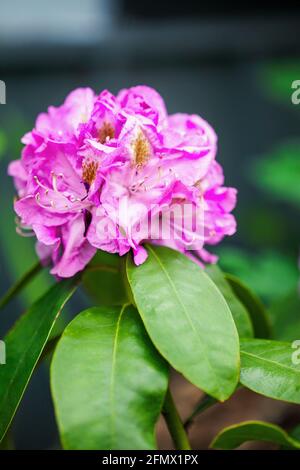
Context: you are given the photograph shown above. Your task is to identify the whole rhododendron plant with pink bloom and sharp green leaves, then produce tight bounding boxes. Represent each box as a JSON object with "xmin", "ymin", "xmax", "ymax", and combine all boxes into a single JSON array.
[{"xmin": 0, "ymin": 86, "xmax": 300, "ymax": 449}]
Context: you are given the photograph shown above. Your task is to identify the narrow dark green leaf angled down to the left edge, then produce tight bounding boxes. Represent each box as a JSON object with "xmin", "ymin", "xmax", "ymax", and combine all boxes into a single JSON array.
[{"xmin": 0, "ymin": 279, "xmax": 77, "ymax": 441}]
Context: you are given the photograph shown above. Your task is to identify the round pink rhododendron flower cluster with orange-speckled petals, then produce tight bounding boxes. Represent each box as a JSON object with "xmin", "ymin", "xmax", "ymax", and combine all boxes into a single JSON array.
[{"xmin": 9, "ymin": 86, "xmax": 236, "ymax": 277}]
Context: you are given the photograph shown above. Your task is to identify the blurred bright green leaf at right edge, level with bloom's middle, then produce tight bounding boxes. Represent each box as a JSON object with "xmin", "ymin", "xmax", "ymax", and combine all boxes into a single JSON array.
[{"xmin": 252, "ymin": 143, "xmax": 300, "ymax": 208}]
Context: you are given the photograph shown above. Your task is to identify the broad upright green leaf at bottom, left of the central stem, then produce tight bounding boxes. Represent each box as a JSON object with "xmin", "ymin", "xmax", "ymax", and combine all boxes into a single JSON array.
[{"xmin": 51, "ymin": 306, "xmax": 168, "ymax": 450}]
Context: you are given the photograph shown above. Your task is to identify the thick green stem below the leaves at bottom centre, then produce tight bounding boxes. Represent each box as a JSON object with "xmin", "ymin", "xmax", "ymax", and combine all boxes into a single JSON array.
[{"xmin": 162, "ymin": 389, "xmax": 191, "ymax": 450}]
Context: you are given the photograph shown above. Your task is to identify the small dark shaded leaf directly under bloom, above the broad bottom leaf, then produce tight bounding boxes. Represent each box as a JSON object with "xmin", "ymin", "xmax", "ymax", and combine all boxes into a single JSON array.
[{"xmin": 82, "ymin": 250, "xmax": 126, "ymax": 305}]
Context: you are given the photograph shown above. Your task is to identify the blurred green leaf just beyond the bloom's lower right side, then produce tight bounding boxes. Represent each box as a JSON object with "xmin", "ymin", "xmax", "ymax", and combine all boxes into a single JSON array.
[{"xmin": 219, "ymin": 247, "xmax": 299, "ymax": 303}]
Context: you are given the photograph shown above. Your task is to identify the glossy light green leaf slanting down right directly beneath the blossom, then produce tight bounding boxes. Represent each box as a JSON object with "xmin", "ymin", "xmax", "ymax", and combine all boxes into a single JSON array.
[{"xmin": 127, "ymin": 246, "xmax": 239, "ymax": 401}]
